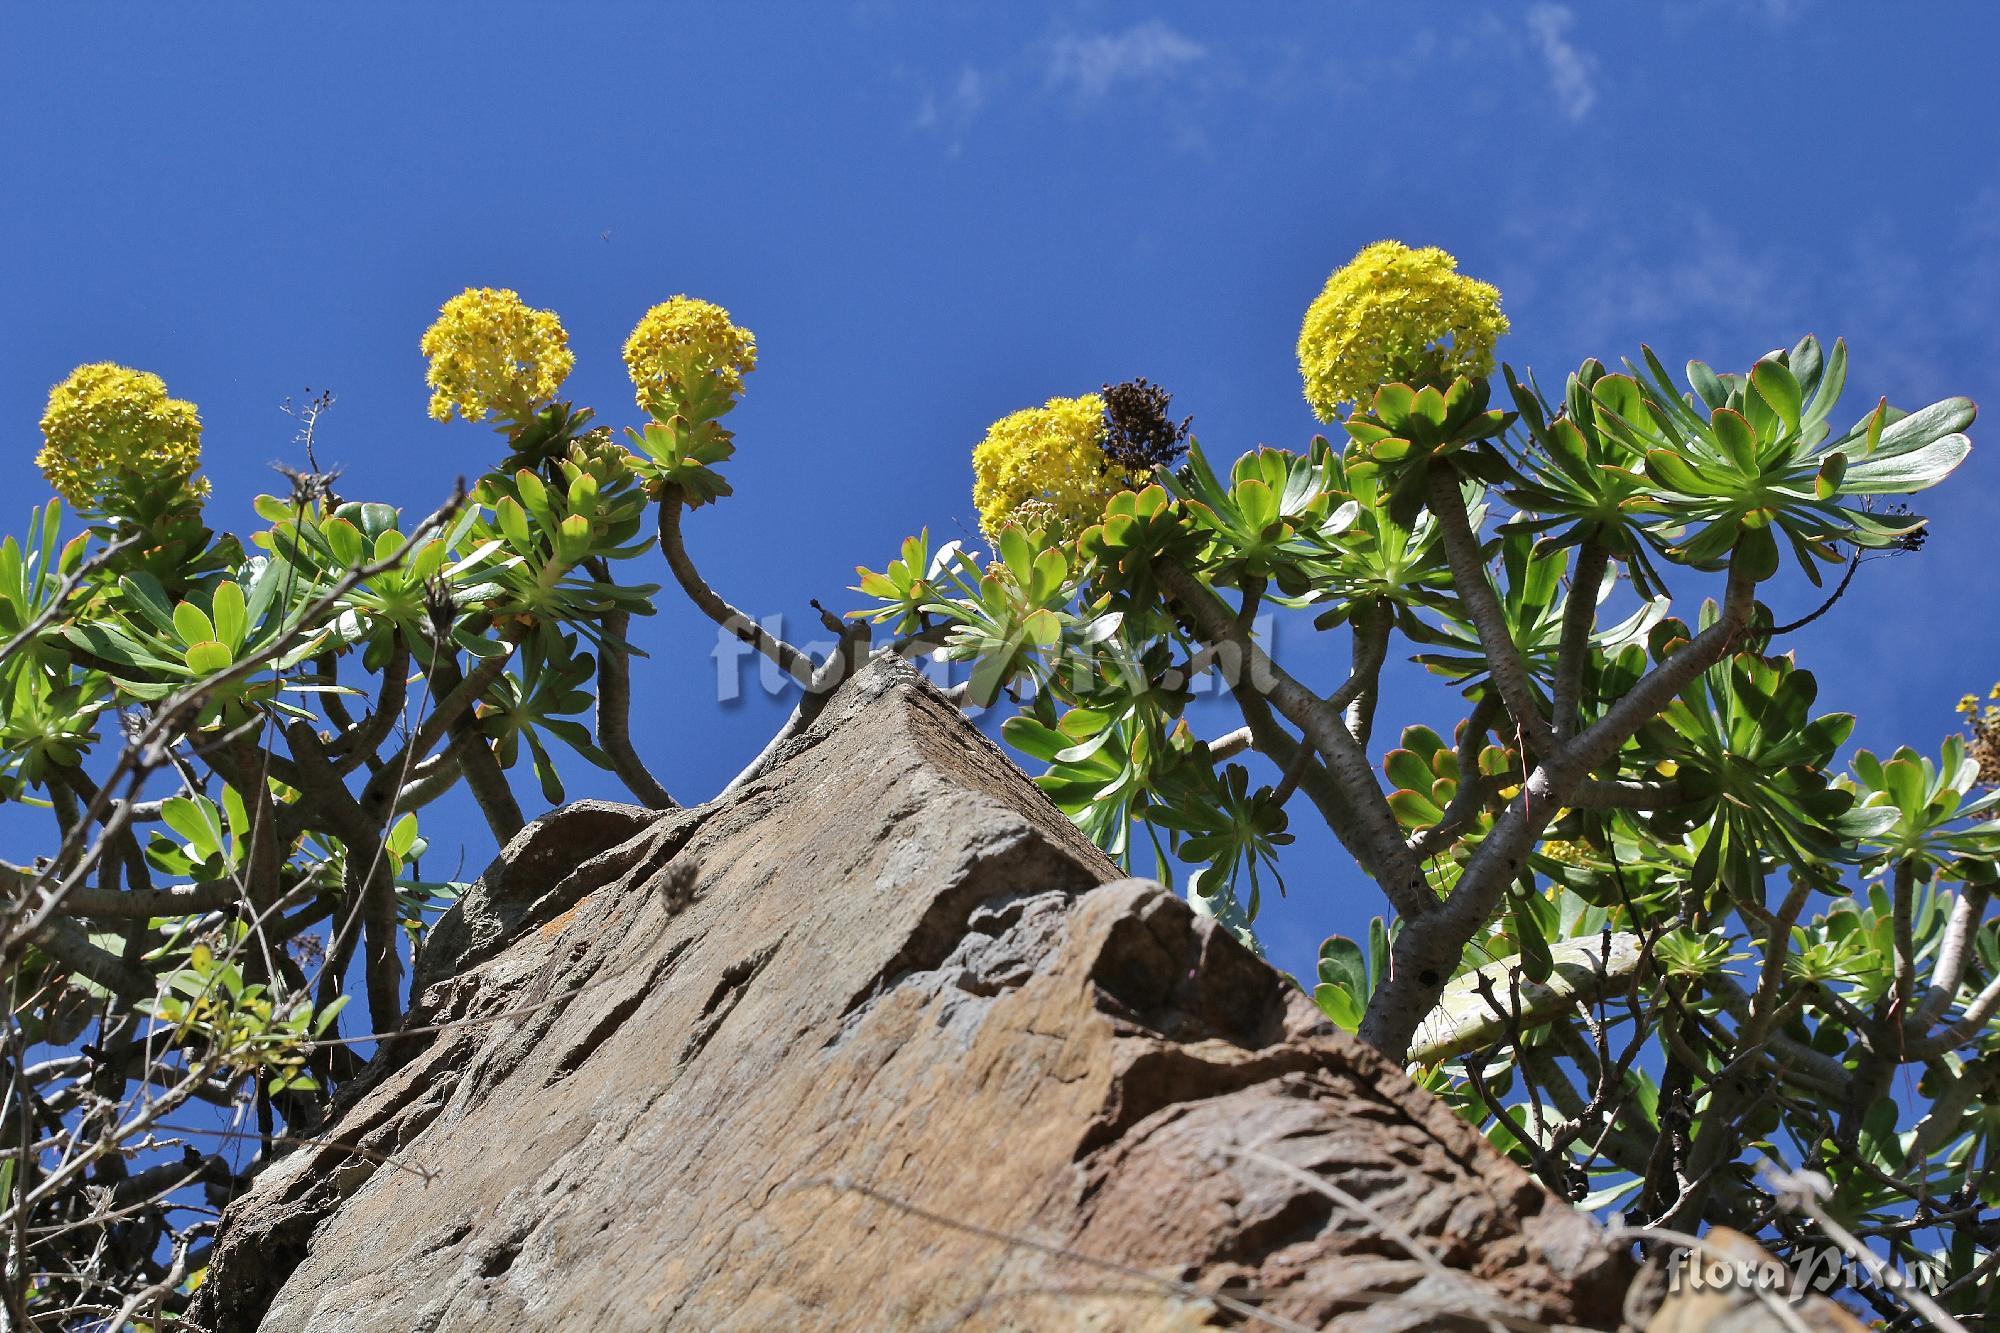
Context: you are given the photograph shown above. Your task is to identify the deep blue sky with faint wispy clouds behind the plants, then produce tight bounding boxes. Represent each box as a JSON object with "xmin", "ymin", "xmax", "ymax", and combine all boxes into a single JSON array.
[{"xmin": 0, "ymin": 0, "xmax": 2000, "ymax": 967}]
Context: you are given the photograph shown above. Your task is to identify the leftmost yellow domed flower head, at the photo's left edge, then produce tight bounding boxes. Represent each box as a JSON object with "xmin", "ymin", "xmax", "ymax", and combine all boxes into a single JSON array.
[{"xmin": 36, "ymin": 360, "xmax": 208, "ymax": 514}]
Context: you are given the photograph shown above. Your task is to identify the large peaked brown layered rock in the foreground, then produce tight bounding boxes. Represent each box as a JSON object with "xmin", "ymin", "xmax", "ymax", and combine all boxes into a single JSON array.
[{"xmin": 192, "ymin": 662, "xmax": 1630, "ymax": 1333}]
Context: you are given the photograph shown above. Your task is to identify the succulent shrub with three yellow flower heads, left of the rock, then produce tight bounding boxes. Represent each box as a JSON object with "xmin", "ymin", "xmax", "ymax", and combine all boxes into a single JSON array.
[{"xmin": 0, "ymin": 288, "xmax": 900, "ymax": 1317}]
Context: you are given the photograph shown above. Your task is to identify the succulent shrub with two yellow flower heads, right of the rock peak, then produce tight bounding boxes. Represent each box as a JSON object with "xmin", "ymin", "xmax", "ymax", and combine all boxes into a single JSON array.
[{"xmin": 858, "ymin": 240, "xmax": 2000, "ymax": 1304}]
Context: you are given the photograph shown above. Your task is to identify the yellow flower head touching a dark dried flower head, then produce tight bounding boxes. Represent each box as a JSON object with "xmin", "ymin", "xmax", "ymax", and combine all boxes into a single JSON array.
[{"xmin": 972, "ymin": 394, "xmax": 1136, "ymax": 540}]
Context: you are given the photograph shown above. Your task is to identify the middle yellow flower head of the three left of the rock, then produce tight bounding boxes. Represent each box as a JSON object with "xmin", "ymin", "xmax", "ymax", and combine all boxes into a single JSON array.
[{"xmin": 422, "ymin": 286, "xmax": 576, "ymax": 422}]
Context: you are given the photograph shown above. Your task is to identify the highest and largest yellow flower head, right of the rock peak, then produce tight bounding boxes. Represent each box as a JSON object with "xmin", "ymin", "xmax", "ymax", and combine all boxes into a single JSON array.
[{"xmin": 1298, "ymin": 240, "xmax": 1506, "ymax": 420}]
